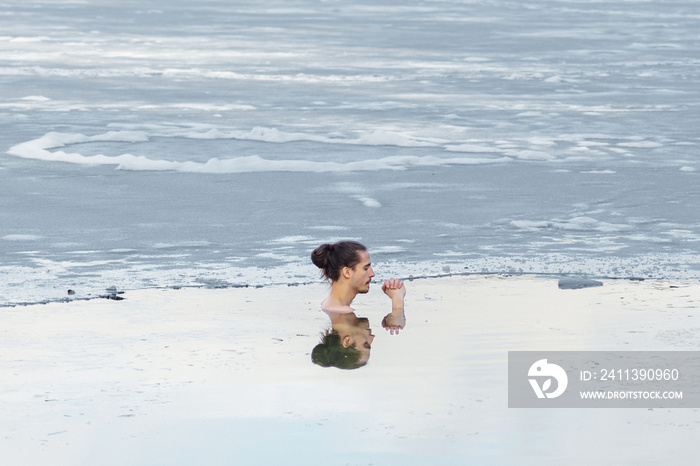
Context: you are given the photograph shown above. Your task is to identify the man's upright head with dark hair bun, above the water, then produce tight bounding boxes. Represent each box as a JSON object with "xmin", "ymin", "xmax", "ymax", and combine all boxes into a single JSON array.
[{"xmin": 311, "ymin": 241, "xmax": 374, "ymax": 293}]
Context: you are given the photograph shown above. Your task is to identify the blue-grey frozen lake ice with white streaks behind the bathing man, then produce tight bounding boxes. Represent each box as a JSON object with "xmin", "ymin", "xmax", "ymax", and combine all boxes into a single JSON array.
[{"xmin": 0, "ymin": 0, "xmax": 700, "ymax": 305}]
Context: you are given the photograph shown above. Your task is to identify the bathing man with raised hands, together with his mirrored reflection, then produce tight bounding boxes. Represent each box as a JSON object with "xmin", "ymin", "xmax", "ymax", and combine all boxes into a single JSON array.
[{"xmin": 311, "ymin": 241, "xmax": 406, "ymax": 369}]
